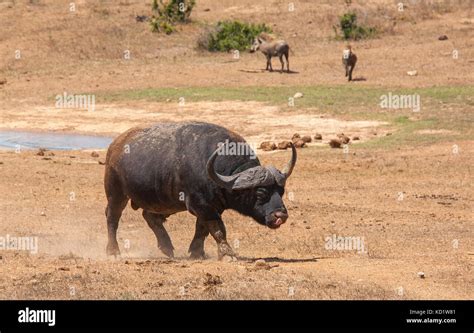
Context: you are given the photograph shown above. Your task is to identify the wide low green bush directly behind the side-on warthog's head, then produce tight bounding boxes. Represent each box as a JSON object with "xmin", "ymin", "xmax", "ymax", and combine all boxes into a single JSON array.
[{"xmin": 202, "ymin": 21, "xmax": 272, "ymax": 52}]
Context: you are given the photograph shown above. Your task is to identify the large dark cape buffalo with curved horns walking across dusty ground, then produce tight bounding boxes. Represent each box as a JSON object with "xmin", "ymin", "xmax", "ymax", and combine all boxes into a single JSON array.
[{"xmin": 104, "ymin": 122, "xmax": 296, "ymax": 259}]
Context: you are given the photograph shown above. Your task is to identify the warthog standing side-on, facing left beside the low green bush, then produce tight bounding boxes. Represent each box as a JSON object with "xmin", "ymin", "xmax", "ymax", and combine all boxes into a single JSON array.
[{"xmin": 250, "ymin": 35, "xmax": 290, "ymax": 73}]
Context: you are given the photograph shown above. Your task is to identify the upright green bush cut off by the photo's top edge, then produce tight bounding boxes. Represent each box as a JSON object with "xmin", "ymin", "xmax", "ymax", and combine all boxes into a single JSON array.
[{"xmin": 150, "ymin": 0, "xmax": 196, "ymax": 35}]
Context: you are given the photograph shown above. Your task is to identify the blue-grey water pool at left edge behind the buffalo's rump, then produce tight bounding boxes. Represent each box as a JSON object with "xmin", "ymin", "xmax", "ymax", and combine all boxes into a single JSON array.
[{"xmin": 0, "ymin": 130, "xmax": 113, "ymax": 150}]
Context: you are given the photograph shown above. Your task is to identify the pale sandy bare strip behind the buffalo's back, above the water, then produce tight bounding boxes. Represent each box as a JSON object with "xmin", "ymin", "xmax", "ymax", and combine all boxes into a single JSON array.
[{"xmin": 0, "ymin": 101, "xmax": 387, "ymax": 145}]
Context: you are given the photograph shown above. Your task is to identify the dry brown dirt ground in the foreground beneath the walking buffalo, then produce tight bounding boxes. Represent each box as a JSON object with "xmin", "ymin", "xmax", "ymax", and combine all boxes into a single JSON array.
[{"xmin": 0, "ymin": 142, "xmax": 474, "ymax": 299}]
